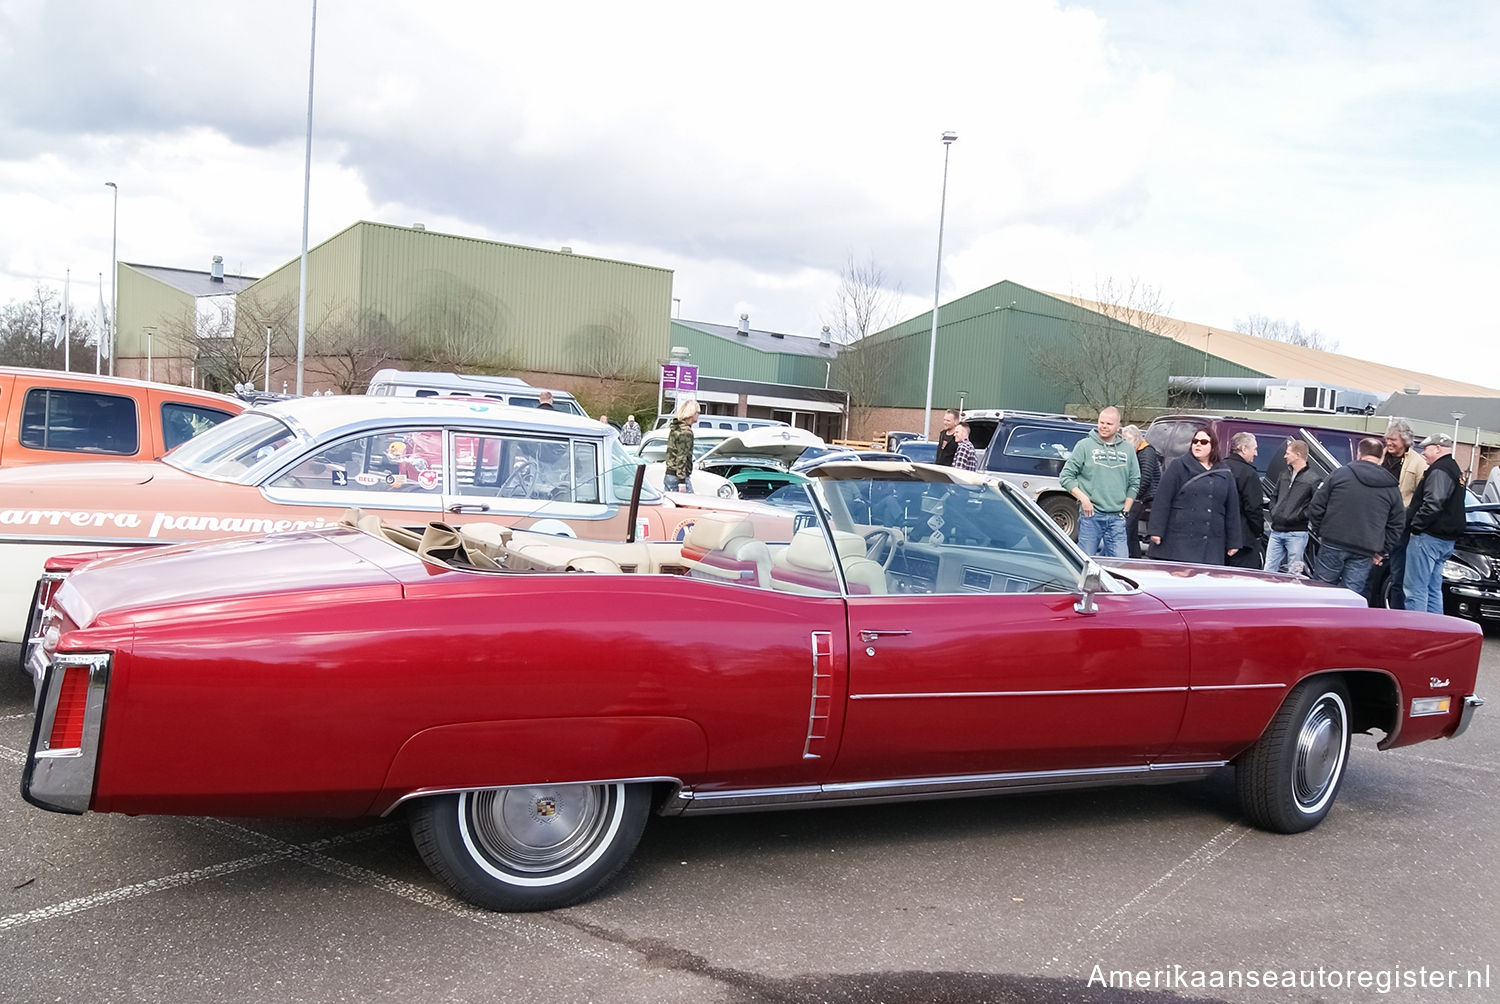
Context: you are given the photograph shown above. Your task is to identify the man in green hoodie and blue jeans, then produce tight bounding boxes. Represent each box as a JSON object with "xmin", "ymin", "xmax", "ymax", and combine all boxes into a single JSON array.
[{"xmin": 1059, "ymin": 408, "xmax": 1140, "ymax": 558}]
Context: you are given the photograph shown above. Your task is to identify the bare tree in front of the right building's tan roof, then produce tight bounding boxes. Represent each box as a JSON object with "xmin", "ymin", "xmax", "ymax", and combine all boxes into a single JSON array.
[{"xmin": 1032, "ymin": 279, "xmax": 1178, "ymax": 416}]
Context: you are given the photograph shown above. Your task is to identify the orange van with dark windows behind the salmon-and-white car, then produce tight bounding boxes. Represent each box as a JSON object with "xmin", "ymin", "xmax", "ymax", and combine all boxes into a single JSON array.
[{"xmin": 0, "ymin": 366, "xmax": 245, "ymax": 467}]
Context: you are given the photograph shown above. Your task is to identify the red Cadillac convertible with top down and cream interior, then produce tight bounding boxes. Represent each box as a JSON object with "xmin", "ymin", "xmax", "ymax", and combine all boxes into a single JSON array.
[{"xmin": 23, "ymin": 462, "xmax": 1482, "ymax": 909}]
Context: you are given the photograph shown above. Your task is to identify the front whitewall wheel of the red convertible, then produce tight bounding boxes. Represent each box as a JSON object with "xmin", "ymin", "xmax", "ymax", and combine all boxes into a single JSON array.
[{"xmin": 1236, "ymin": 677, "xmax": 1350, "ymax": 833}]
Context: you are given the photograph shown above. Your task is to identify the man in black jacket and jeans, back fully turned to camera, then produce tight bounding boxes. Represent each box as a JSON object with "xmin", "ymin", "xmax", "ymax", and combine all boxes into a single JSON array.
[{"xmin": 1308, "ymin": 438, "xmax": 1406, "ymax": 594}]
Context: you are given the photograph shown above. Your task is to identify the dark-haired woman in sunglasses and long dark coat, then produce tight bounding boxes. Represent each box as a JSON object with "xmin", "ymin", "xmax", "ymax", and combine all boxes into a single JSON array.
[{"xmin": 1151, "ymin": 428, "xmax": 1244, "ymax": 564}]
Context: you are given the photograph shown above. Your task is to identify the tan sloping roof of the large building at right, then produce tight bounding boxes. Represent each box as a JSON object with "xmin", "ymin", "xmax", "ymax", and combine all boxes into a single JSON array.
[{"xmin": 1049, "ymin": 293, "xmax": 1500, "ymax": 396}]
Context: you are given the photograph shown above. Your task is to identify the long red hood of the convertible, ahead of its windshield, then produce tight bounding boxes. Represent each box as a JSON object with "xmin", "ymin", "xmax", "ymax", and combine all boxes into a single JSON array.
[{"xmin": 1100, "ymin": 558, "xmax": 1367, "ymax": 611}]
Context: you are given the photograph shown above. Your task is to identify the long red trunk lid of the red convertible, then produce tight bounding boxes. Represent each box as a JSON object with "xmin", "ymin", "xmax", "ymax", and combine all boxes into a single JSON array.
[{"xmin": 54, "ymin": 527, "xmax": 414, "ymax": 627}]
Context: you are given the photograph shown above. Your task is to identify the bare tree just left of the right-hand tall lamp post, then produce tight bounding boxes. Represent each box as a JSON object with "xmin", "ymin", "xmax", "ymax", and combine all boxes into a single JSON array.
[{"xmin": 824, "ymin": 252, "xmax": 902, "ymax": 432}]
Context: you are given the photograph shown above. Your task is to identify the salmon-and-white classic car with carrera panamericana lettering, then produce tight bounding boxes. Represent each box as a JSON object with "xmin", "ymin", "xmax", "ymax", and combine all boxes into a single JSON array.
[{"xmin": 0, "ymin": 396, "xmax": 791, "ymax": 641}]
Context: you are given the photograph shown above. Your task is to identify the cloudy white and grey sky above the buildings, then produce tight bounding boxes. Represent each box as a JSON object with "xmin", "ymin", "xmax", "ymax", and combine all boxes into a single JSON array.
[{"xmin": 0, "ymin": 0, "xmax": 1500, "ymax": 387}]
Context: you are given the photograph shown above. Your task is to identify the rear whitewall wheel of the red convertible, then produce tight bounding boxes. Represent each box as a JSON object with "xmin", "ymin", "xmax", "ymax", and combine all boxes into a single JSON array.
[{"xmin": 411, "ymin": 783, "xmax": 651, "ymax": 911}]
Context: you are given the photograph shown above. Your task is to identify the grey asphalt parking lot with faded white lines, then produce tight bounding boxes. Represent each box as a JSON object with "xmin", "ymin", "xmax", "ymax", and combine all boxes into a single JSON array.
[{"xmin": 0, "ymin": 633, "xmax": 1500, "ymax": 1002}]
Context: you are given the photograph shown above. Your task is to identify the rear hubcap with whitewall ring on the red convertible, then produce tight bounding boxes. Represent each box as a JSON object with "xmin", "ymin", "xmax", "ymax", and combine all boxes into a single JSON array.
[{"xmin": 462, "ymin": 785, "xmax": 620, "ymax": 875}]
